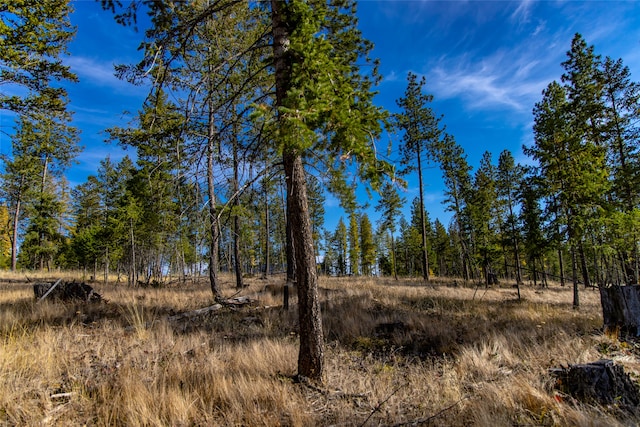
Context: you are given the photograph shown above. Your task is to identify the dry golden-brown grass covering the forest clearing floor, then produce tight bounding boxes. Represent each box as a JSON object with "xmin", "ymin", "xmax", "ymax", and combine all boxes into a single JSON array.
[{"xmin": 0, "ymin": 275, "xmax": 640, "ymax": 426}]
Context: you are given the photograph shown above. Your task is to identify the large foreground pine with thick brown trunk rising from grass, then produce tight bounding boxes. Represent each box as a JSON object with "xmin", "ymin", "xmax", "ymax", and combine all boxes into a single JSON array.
[{"xmin": 103, "ymin": 0, "xmax": 392, "ymax": 380}]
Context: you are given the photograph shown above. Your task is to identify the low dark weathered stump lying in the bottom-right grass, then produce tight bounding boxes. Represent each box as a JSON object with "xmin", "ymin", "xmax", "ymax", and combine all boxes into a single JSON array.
[{"xmin": 551, "ymin": 360, "xmax": 640, "ymax": 411}]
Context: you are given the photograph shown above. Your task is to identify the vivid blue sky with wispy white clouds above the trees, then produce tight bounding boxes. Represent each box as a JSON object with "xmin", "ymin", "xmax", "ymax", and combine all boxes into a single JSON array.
[{"xmin": 0, "ymin": 0, "xmax": 640, "ymax": 234}]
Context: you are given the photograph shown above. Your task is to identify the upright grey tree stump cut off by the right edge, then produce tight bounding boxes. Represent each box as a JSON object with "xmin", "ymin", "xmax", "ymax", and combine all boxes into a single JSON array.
[{"xmin": 600, "ymin": 285, "xmax": 640, "ymax": 337}]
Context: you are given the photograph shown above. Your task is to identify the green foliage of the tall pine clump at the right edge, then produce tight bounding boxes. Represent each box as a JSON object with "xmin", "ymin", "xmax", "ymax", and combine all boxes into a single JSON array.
[{"xmin": 525, "ymin": 34, "xmax": 640, "ymax": 290}]
